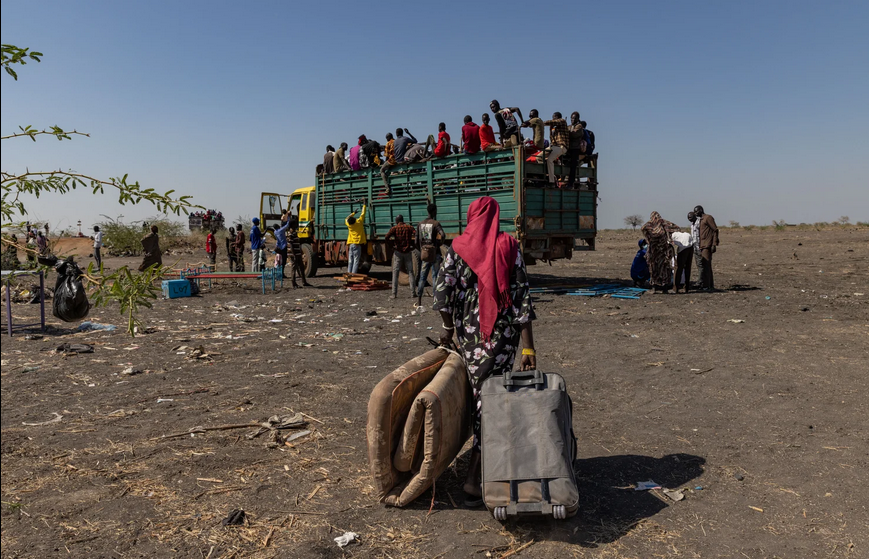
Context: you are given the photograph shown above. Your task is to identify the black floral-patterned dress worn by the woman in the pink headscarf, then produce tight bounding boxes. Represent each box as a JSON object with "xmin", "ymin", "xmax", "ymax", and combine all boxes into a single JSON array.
[{"xmin": 434, "ymin": 248, "xmax": 537, "ymax": 448}]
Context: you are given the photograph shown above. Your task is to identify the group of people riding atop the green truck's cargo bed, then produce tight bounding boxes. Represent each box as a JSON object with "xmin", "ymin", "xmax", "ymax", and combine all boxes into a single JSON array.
[{"xmin": 317, "ymin": 100, "xmax": 595, "ymax": 193}]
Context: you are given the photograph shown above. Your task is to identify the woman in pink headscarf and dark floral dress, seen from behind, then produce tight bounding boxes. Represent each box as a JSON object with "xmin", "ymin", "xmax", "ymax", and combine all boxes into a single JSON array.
[{"xmin": 434, "ymin": 196, "xmax": 537, "ymax": 506}]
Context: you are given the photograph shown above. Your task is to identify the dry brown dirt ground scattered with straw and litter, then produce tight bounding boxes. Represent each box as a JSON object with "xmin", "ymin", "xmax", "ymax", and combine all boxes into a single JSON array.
[{"xmin": 2, "ymin": 228, "xmax": 869, "ymax": 559}]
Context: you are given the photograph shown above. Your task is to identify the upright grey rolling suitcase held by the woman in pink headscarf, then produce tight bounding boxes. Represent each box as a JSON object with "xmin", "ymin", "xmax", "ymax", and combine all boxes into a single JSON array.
[{"xmin": 480, "ymin": 371, "xmax": 579, "ymax": 521}]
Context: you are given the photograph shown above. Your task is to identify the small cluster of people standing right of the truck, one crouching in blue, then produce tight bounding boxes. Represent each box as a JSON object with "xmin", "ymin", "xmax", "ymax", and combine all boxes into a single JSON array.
[{"xmin": 631, "ymin": 206, "xmax": 719, "ymax": 293}]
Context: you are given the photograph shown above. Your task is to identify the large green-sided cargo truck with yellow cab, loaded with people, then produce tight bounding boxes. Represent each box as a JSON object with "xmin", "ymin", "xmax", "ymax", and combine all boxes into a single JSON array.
[{"xmin": 260, "ymin": 147, "xmax": 598, "ymax": 273}]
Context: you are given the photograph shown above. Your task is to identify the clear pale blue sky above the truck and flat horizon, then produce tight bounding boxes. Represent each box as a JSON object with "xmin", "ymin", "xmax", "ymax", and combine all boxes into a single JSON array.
[{"xmin": 0, "ymin": 0, "xmax": 869, "ymax": 232}]
